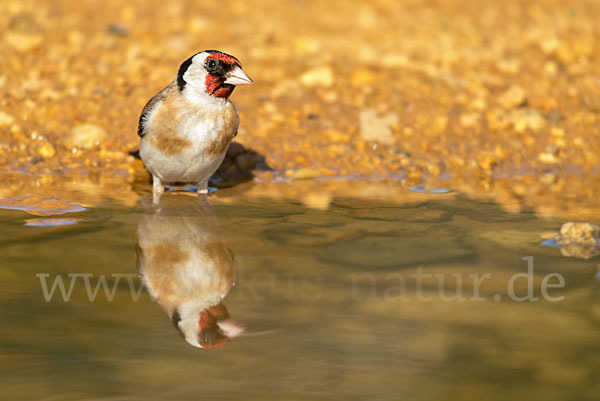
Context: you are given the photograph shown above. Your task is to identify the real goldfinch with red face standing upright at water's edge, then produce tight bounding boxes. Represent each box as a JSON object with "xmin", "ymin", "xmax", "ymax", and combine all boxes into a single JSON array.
[{"xmin": 138, "ymin": 50, "xmax": 254, "ymax": 202}]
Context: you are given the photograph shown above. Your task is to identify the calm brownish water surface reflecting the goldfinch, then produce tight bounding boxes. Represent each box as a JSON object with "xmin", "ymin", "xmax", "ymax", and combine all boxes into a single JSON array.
[{"xmin": 0, "ymin": 185, "xmax": 600, "ymax": 400}]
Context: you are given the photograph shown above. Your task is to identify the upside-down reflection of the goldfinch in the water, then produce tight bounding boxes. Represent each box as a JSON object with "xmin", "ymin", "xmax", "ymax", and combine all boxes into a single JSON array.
[{"xmin": 136, "ymin": 193, "xmax": 243, "ymax": 348}]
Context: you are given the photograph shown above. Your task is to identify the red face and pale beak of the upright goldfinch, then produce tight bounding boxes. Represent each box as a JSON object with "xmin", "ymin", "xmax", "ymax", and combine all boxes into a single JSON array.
[{"xmin": 204, "ymin": 52, "xmax": 254, "ymax": 98}]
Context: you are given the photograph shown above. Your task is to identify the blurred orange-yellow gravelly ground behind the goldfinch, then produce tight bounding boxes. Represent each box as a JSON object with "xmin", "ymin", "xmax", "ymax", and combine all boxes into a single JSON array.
[{"xmin": 0, "ymin": 0, "xmax": 600, "ymax": 219}]
